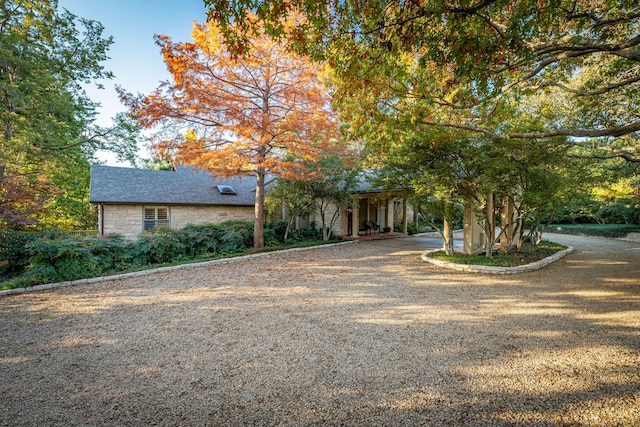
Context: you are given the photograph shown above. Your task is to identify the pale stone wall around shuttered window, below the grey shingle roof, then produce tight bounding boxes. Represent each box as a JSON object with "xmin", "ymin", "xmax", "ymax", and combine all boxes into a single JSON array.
[{"xmin": 99, "ymin": 205, "xmax": 254, "ymax": 240}]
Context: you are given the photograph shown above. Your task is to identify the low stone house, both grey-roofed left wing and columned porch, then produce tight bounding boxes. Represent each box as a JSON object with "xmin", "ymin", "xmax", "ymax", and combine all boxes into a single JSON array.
[{"xmin": 89, "ymin": 165, "xmax": 407, "ymax": 240}]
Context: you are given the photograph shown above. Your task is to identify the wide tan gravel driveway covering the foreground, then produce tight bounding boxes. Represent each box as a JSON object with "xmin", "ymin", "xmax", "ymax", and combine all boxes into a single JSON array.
[{"xmin": 0, "ymin": 235, "xmax": 640, "ymax": 426}]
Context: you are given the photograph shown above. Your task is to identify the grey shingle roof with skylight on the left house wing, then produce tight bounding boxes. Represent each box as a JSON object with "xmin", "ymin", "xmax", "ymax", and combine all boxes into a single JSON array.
[{"xmin": 89, "ymin": 165, "xmax": 256, "ymax": 206}]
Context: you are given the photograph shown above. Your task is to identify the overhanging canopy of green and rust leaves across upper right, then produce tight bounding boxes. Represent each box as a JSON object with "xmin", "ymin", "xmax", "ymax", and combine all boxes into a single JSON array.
[{"xmin": 204, "ymin": 0, "xmax": 640, "ymax": 161}]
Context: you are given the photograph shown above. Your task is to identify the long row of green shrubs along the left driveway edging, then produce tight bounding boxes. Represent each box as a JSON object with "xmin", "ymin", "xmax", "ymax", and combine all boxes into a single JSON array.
[{"xmin": 0, "ymin": 221, "xmax": 317, "ymax": 289}]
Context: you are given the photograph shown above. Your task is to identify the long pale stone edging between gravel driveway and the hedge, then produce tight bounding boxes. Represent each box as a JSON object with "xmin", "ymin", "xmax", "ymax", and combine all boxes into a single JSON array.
[{"xmin": 0, "ymin": 240, "xmax": 355, "ymax": 297}]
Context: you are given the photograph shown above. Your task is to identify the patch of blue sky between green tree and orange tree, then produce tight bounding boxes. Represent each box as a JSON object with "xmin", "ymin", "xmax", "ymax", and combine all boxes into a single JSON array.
[{"xmin": 58, "ymin": 0, "xmax": 205, "ymax": 164}]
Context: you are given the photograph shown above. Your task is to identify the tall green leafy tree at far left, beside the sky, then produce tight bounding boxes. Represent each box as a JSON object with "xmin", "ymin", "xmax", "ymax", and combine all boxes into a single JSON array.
[{"xmin": 0, "ymin": 0, "xmax": 138, "ymax": 231}]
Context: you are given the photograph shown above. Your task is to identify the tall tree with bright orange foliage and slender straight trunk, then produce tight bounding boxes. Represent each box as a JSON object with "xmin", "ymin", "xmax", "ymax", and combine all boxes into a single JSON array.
[{"xmin": 120, "ymin": 18, "xmax": 337, "ymax": 247}]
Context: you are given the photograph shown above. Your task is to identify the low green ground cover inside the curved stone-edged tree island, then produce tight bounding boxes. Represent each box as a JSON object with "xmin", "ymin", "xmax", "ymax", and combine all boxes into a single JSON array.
[{"xmin": 427, "ymin": 240, "xmax": 567, "ymax": 267}]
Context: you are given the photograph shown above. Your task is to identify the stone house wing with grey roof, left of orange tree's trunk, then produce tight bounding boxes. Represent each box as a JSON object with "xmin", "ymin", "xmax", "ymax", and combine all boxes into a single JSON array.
[{"xmin": 89, "ymin": 165, "xmax": 256, "ymax": 240}]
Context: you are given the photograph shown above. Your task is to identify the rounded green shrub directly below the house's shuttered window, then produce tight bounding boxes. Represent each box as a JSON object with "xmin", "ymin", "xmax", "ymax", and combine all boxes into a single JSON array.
[{"xmin": 132, "ymin": 228, "xmax": 185, "ymax": 265}]
